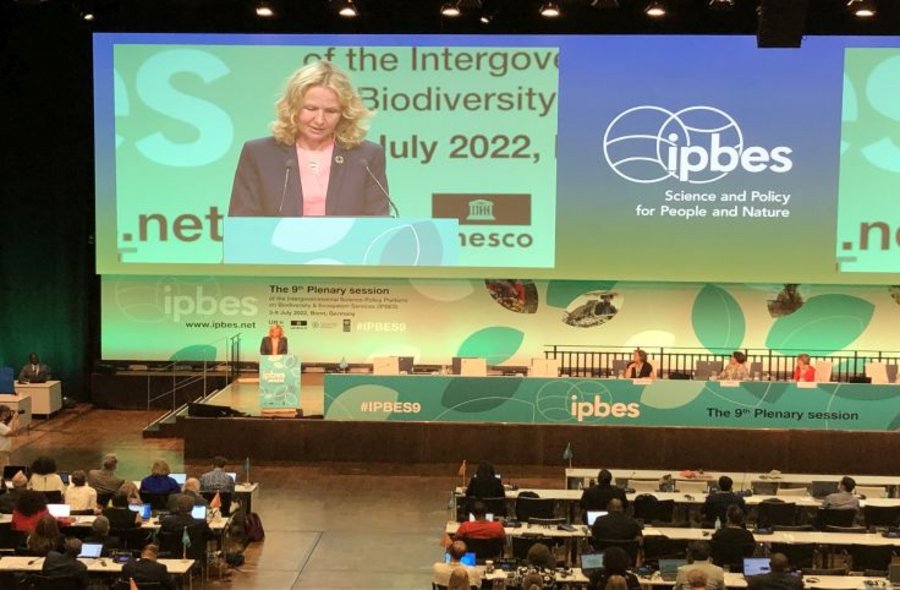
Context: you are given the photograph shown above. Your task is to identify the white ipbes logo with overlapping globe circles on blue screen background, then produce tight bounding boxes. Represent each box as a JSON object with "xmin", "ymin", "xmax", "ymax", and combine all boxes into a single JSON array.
[{"xmin": 603, "ymin": 105, "xmax": 794, "ymax": 184}]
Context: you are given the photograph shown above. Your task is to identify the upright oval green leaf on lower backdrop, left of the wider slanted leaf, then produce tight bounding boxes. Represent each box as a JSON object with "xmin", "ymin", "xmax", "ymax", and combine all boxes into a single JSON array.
[{"xmin": 691, "ymin": 285, "xmax": 746, "ymax": 352}]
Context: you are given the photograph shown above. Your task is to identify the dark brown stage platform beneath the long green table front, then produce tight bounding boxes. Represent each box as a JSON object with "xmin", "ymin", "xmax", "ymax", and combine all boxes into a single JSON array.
[{"xmin": 183, "ymin": 373, "xmax": 900, "ymax": 475}]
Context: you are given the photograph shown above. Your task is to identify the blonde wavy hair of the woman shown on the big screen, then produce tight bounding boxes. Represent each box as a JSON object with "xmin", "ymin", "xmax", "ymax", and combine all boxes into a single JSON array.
[{"xmin": 271, "ymin": 60, "xmax": 372, "ymax": 148}]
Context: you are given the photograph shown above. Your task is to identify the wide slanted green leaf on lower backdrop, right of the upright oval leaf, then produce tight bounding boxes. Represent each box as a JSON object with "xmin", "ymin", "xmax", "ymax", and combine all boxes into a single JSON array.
[{"xmin": 766, "ymin": 295, "xmax": 875, "ymax": 354}]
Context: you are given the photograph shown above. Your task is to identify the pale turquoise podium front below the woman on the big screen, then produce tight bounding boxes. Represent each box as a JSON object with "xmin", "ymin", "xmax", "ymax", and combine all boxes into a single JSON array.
[{"xmin": 223, "ymin": 217, "xmax": 459, "ymax": 266}]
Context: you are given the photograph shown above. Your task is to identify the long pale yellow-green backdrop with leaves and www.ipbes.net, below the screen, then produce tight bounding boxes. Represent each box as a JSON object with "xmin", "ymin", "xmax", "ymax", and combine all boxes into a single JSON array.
[{"xmin": 102, "ymin": 276, "xmax": 900, "ymax": 372}]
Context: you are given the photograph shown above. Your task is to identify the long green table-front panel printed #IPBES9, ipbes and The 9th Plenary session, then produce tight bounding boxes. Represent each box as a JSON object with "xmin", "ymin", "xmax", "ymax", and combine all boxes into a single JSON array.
[{"xmin": 325, "ymin": 374, "xmax": 900, "ymax": 432}]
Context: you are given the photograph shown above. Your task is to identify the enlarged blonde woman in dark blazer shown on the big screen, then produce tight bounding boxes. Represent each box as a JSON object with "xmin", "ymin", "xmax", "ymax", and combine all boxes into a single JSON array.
[{"xmin": 228, "ymin": 61, "xmax": 389, "ymax": 217}]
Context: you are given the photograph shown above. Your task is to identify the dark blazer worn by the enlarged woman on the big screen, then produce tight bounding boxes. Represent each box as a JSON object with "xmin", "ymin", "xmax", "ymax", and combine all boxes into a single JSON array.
[{"xmin": 228, "ymin": 137, "xmax": 389, "ymax": 217}]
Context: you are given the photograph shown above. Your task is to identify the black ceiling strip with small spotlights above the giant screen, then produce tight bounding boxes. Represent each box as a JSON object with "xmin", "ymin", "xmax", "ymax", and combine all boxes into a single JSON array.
[{"xmin": 0, "ymin": 0, "xmax": 900, "ymax": 35}]
